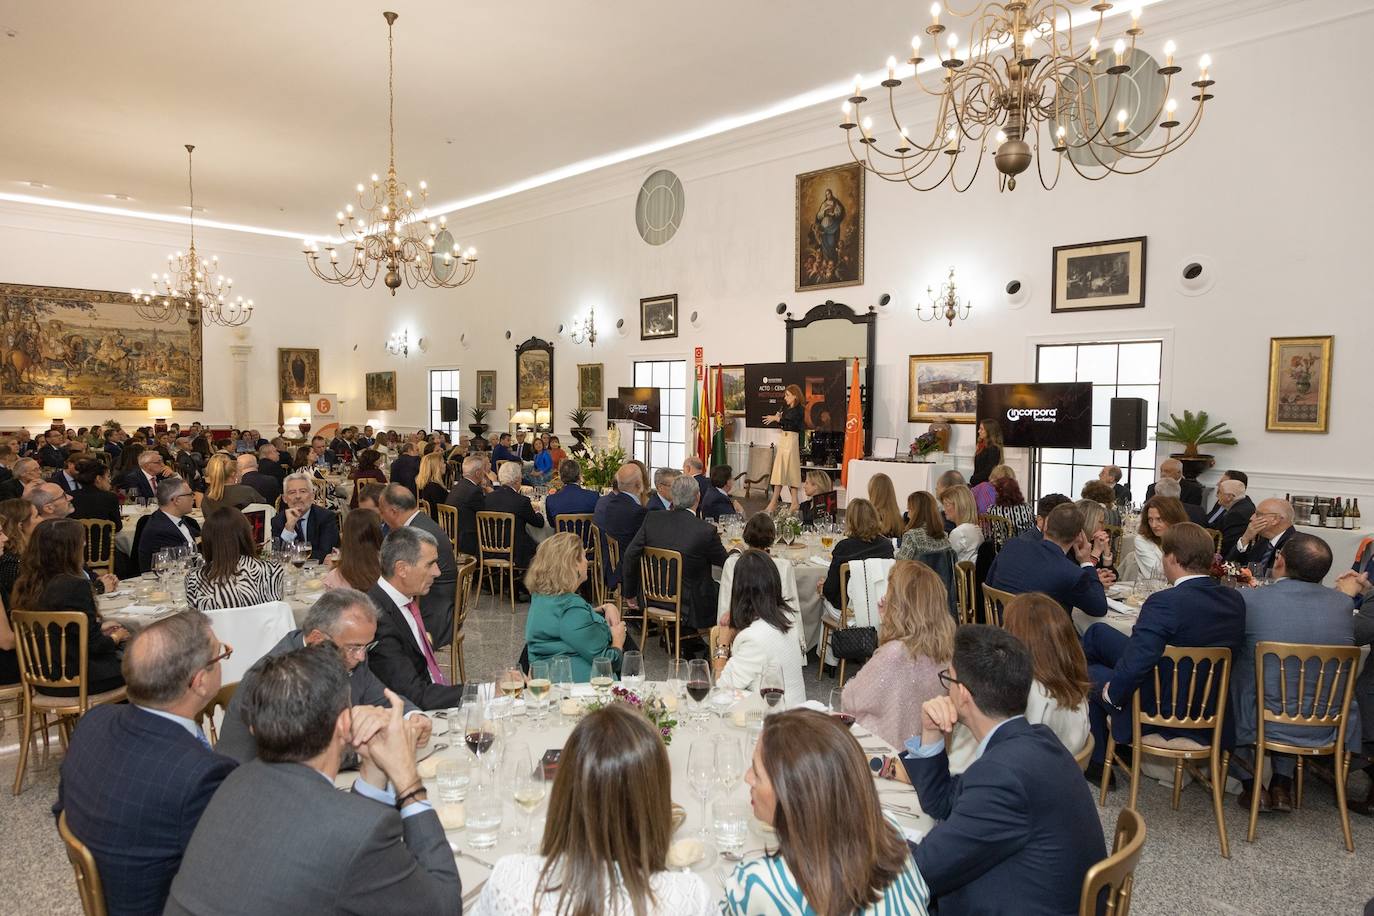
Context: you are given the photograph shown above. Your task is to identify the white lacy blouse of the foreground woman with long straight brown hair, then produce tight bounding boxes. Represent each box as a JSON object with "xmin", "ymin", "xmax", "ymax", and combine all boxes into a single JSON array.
[{"xmin": 471, "ymin": 856, "xmax": 720, "ymax": 916}]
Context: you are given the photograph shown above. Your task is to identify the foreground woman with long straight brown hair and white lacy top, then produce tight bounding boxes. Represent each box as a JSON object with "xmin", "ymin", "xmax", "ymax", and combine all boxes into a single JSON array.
[{"xmin": 473, "ymin": 703, "xmax": 714, "ymax": 916}]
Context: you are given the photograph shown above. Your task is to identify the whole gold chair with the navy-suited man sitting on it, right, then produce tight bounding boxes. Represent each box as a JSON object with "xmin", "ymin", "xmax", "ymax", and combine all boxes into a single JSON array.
[{"xmin": 1098, "ymin": 645, "xmax": 1231, "ymax": 858}]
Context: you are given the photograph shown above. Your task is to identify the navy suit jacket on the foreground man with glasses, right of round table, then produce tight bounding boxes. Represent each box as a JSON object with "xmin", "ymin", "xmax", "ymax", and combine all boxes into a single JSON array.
[{"xmin": 901, "ymin": 718, "xmax": 1106, "ymax": 916}]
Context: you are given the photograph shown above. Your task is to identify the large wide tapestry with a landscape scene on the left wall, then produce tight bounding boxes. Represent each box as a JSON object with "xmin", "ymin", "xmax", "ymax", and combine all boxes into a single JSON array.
[{"xmin": 0, "ymin": 283, "xmax": 205, "ymax": 411}]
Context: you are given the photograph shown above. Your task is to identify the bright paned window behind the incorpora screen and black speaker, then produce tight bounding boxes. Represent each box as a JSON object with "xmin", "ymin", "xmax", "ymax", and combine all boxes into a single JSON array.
[{"xmin": 1033, "ymin": 341, "xmax": 1164, "ymax": 503}]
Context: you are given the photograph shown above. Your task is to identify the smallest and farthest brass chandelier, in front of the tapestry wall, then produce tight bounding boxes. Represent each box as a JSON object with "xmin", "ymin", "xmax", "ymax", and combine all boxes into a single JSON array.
[{"xmin": 129, "ymin": 143, "xmax": 253, "ymax": 327}]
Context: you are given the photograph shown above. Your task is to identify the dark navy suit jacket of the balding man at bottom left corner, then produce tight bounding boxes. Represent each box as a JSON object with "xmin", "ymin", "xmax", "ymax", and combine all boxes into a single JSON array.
[{"xmin": 52, "ymin": 705, "xmax": 238, "ymax": 916}]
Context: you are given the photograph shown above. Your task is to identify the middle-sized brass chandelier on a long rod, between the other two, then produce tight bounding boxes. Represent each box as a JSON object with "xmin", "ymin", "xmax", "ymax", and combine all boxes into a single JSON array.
[{"xmin": 304, "ymin": 12, "xmax": 477, "ymax": 295}]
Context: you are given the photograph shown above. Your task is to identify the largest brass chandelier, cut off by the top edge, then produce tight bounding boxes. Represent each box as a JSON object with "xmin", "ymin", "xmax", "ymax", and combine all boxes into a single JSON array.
[{"xmin": 840, "ymin": 0, "xmax": 1215, "ymax": 192}]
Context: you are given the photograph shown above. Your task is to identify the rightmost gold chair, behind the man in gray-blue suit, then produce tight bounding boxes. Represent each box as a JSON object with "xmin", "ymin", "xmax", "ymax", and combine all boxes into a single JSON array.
[{"xmin": 1245, "ymin": 641, "xmax": 1360, "ymax": 853}]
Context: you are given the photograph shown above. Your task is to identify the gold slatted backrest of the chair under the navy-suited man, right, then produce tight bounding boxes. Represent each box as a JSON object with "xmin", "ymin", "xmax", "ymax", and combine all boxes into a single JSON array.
[{"xmin": 1131, "ymin": 645, "xmax": 1231, "ymax": 747}]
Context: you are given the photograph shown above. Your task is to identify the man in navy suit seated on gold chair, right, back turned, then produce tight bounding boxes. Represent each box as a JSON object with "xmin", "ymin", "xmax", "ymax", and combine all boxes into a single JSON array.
[{"xmin": 1083, "ymin": 522, "xmax": 1245, "ymax": 780}]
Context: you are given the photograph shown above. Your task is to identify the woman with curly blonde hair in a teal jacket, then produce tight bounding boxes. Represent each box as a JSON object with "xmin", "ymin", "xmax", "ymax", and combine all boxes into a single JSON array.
[{"xmin": 525, "ymin": 531, "xmax": 625, "ymax": 681}]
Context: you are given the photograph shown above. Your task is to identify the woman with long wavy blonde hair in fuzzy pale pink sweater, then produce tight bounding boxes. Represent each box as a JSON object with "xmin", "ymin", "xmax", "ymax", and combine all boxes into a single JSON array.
[{"xmin": 844, "ymin": 560, "xmax": 956, "ymax": 747}]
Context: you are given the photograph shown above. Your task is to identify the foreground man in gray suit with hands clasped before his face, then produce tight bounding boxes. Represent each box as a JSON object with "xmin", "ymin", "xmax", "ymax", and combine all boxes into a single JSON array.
[{"xmin": 164, "ymin": 645, "xmax": 463, "ymax": 916}]
